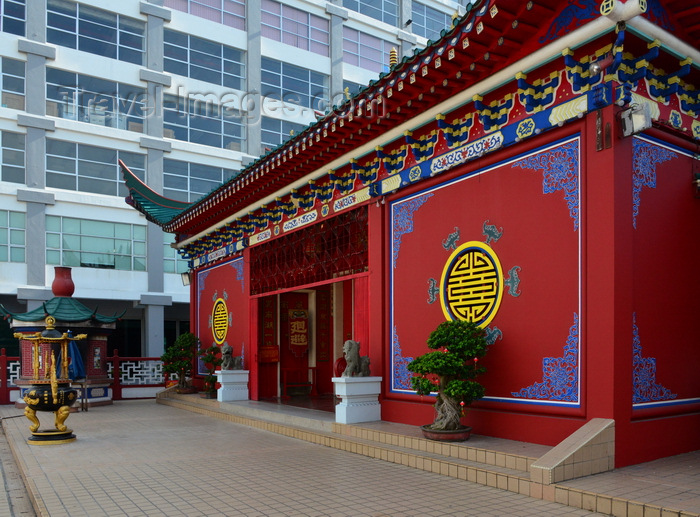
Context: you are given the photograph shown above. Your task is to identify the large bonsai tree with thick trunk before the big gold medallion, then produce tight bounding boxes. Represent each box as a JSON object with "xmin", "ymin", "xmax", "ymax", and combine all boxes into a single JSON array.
[{"xmin": 407, "ymin": 321, "xmax": 488, "ymax": 431}]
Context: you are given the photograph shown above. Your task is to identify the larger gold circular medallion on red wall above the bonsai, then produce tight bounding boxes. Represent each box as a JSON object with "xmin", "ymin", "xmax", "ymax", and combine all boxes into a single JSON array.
[{"xmin": 440, "ymin": 241, "xmax": 503, "ymax": 327}]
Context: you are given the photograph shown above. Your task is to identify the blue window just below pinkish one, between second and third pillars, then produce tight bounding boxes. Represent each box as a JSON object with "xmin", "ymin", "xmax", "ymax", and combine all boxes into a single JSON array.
[{"xmin": 164, "ymin": 29, "xmax": 245, "ymax": 90}]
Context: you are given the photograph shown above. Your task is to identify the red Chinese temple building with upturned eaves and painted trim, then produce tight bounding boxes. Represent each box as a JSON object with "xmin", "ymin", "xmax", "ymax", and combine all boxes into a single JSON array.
[{"xmin": 122, "ymin": 0, "xmax": 700, "ymax": 467}]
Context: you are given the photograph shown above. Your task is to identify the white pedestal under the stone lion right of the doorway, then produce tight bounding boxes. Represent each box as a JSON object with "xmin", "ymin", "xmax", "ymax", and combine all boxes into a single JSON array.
[{"xmin": 333, "ymin": 377, "xmax": 382, "ymax": 424}]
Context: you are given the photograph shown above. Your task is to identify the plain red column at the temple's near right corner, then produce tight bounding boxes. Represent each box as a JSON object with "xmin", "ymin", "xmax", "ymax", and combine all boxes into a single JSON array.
[{"xmin": 581, "ymin": 106, "xmax": 633, "ymax": 464}]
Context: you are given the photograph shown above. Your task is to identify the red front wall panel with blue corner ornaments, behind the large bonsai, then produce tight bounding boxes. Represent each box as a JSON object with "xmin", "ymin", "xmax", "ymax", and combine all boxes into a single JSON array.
[{"xmin": 385, "ymin": 134, "xmax": 582, "ymax": 434}]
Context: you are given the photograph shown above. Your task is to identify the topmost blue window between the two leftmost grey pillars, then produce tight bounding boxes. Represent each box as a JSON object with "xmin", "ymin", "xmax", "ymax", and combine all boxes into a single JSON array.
[{"xmin": 46, "ymin": 0, "xmax": 146, "ymax": 65}]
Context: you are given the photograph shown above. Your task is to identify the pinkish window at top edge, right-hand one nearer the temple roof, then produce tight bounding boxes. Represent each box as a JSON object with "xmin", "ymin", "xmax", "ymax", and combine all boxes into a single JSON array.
[{"xmin": 262, "ymin": 0, "xmax": 330, "ymax": 56}]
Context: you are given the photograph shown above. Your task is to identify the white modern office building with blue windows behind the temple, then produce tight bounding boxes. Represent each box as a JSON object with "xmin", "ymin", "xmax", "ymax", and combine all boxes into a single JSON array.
[{"xmin": 0, "ymin": 0, "xmax": 465, "ymax": 356}]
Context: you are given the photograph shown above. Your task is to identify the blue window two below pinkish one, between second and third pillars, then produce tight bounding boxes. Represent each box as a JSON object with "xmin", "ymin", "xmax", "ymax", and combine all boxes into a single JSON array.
[{"xmin": 163, "ymin": 95, "xmax": 244, "ymax": 151}]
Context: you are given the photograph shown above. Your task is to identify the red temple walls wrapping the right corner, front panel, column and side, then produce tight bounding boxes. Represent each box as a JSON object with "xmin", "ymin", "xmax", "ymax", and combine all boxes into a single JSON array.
[{"xmin": 382, "ymin": 120, "xmax": 700, "ymax": 466}]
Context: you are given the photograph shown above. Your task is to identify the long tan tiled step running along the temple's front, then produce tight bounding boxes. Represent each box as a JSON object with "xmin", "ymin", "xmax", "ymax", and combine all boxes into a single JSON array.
[{"xmin": 157, "ymin": 390, "xmax": 700, "ymax": 517}]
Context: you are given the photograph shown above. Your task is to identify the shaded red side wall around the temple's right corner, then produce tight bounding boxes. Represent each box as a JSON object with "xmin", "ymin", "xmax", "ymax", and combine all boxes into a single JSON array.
[{"xmin": 617, "ymin": 136, "xmax": 700, "ymax": 464}]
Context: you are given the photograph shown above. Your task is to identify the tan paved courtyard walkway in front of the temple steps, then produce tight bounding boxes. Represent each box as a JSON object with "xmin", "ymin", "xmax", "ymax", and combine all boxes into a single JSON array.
[{"xmin": 0, "ymin": 400, "xmax": 600, "ymax": 517}]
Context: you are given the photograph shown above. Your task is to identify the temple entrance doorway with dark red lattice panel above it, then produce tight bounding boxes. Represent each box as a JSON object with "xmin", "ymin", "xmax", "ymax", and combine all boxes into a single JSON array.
[{"xmin": 247, "ymin": 206, "xmax": 369, "ymax": 410}]
